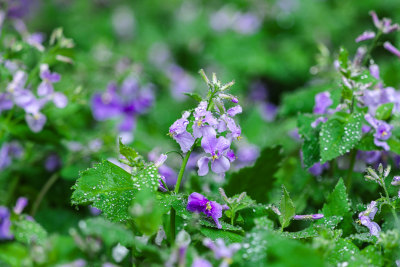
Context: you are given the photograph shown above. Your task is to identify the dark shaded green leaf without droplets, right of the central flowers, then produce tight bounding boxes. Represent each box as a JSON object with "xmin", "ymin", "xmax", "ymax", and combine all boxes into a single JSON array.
[{"xmin": 224, "ymin": 146, "xmax": 283, "ymax": 203}]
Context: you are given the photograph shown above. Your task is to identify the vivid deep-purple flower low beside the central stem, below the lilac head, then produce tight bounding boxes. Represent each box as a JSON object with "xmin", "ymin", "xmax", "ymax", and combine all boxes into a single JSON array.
[{"xmin": 186, "ymin": 192, "xmax": 226, "ymax": 229}]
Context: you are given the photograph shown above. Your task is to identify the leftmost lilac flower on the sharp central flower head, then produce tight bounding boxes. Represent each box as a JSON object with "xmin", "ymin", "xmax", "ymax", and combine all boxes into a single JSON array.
[{"xmin": 169, "ymin": 111, "xmax": 195, "ymax": 153}]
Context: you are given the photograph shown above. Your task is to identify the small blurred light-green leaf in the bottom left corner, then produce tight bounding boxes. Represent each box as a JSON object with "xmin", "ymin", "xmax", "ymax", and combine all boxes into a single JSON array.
[{"xmin": 11, "ymin": 220, "xmax": 47, "ymax": 245}]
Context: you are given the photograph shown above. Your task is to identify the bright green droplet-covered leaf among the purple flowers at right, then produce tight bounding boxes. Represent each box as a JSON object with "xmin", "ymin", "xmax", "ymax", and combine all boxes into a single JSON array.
[{"xmin": 319, "ymin": 112, "xmax": 363, "ymax": 163}]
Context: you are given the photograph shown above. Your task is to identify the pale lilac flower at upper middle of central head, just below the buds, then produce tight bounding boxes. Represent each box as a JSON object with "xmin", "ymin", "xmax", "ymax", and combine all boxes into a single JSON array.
[{"xmin": 193, "ymin": 101, "xmax": 217, "ymax": 138}]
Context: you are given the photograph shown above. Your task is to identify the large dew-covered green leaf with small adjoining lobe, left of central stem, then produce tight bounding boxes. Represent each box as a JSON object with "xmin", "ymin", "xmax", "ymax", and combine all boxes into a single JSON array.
[{"xmin": 72, "ymin": 161, "xmax": 161, "ymax": 222}]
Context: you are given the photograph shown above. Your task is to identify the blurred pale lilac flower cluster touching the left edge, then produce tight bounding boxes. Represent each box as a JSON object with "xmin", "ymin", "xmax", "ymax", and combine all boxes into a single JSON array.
[{"xmin": 0, "ymin": 64, "xmax": 68, "ymax": 133}]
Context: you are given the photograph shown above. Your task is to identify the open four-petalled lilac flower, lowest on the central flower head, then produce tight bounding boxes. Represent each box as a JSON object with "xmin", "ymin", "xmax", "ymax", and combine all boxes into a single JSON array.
[{"xmin": 197, "ymin": 134, "xmax": 231, "ymax": 176}]
